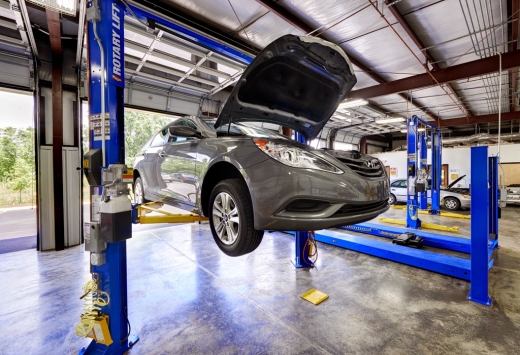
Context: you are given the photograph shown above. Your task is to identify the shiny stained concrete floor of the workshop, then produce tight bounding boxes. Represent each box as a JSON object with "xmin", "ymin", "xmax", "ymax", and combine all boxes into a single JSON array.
[{"xmin": 0, "ymin": 208, "xmax": 520, "ymax": 355}]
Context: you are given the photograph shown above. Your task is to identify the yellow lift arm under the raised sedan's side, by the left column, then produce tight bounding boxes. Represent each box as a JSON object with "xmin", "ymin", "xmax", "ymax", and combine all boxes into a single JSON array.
[{"xmin": 132, "ymin": 202, "xmax": 208, "ymax": 224}]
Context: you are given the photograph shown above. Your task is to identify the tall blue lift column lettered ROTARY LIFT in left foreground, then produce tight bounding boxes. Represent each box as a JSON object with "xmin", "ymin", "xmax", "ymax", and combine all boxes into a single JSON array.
[{"xmin": 79, "ymin": 0, "xmax": 136, "ymax": 355}]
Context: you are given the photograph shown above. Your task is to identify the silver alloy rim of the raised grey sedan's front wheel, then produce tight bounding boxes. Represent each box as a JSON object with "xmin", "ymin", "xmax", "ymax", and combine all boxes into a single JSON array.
[{"xmin": 212, "ymin": 192, "xmax": 240, "ymax": 245}]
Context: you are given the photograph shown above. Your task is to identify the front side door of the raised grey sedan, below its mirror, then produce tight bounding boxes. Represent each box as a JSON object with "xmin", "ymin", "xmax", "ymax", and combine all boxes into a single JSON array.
[{"xmin": 158, "ymin": 120, "xmax": 199, "ymax": 209}]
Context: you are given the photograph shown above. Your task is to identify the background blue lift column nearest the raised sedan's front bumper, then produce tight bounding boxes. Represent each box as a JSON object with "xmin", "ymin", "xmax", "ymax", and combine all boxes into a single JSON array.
[{"xmin": 406, "ymin": 116, "xmax": 421, "ymax": 229}]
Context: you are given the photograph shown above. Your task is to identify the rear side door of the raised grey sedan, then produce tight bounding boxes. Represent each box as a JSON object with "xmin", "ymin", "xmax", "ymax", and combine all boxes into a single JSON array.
[{"xmin": 139, "ymin": 129, "xmax": 168, "ymax": 200}]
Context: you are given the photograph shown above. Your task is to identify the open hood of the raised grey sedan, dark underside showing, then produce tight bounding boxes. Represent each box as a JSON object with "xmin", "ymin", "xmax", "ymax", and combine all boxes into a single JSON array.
[{"xmin": 215, "ymin": 35, "xmax": 357, "ymax": 140}]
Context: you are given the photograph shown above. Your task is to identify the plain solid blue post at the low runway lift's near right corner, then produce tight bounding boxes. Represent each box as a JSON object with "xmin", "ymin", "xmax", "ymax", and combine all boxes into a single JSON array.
[{"xmin": 468, "ymin": 147, "xmax": 492, "ymax": 306}]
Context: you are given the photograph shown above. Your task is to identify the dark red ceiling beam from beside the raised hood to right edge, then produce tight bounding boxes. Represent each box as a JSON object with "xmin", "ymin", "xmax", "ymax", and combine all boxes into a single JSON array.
[{"xmin": 348, "ymin": 50, "xmax": 520, "ymax": 99}]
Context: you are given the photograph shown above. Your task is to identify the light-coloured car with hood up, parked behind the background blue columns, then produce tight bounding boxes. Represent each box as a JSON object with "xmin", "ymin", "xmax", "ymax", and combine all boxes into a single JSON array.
[{"xmin": 388, "ymin": 175, "xmax": 471, "ymax": 211}]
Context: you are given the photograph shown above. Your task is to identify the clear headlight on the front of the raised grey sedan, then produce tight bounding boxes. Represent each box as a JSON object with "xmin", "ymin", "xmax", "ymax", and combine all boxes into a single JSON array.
[{"xmin": 253, "ymin": 139, "xmax": 343, "ymax": 174}]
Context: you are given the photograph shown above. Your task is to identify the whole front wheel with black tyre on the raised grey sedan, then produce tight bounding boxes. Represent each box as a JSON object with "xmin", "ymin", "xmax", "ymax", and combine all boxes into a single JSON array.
[{"xmin": 208, "ymin": 179, "xmax": 264, "ymax": 256}]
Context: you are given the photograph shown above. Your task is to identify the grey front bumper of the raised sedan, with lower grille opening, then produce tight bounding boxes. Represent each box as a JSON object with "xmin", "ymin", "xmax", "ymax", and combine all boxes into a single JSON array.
[{"xmin": 246, "ymin": 159, "xmax": 389, "ymax": 231}]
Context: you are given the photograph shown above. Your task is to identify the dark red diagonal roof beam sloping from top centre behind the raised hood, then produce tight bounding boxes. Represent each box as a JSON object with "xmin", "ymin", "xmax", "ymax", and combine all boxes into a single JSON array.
[{"xmin": 256, "ymin": 0, "xmax": 439, "ymax": 121}]
